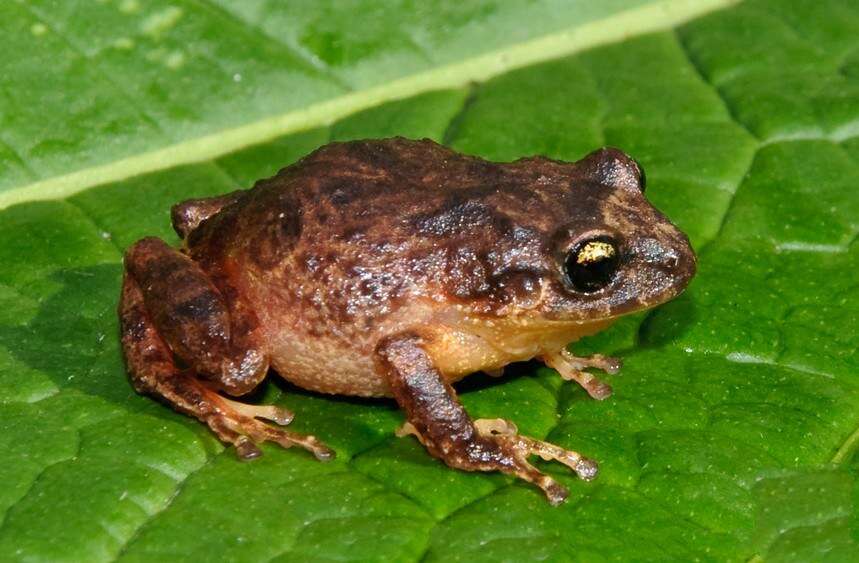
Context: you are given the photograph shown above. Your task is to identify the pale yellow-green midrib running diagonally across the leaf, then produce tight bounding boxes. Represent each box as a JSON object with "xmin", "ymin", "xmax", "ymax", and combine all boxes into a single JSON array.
[{"xmin": 0, "ymin": 0, "xmax": 739, "ymax": 213}]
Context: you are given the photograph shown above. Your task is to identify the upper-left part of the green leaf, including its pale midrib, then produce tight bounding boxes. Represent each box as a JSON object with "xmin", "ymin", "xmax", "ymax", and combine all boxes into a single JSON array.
[{"xmin": 0, "ymin": 0, "xmax": 737, "ymax": 206}]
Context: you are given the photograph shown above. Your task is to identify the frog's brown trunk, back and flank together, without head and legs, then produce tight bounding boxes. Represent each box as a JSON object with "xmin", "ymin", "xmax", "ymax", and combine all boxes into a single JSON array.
[{"xmin": 188, "ymin": 139, "xmax": 600, "ymax": 395}]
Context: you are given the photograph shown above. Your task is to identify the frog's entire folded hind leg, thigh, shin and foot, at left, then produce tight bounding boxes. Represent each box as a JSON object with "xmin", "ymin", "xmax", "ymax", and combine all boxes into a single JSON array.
[{"xmin": 119, "ymin": 238, "xmax": 333, "ymax": 459}]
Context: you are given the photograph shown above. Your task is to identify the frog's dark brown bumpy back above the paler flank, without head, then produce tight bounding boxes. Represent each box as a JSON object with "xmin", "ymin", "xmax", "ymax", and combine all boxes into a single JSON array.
[{"xmin": 188, "ymin": 138, "xmax": 586, "ymax": 306}]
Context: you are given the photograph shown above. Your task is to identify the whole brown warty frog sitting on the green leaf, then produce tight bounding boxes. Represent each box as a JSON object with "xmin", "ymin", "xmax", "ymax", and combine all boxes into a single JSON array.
[{"xmin": 118, "ymin": 137, "xmax": 696, "ymax": 505}]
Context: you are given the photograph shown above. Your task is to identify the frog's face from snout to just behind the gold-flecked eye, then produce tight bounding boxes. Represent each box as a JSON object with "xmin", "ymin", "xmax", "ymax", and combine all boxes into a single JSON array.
[{"xmin": 539, "ymin": 148, "xmax": 696, "ymax": 320}]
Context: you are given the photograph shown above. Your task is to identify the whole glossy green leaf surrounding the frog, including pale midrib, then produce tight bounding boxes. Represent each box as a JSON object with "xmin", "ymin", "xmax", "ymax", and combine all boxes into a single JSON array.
[{"xmin": 0, "ymin": 0, "xmax": 859, "ymax": 561}]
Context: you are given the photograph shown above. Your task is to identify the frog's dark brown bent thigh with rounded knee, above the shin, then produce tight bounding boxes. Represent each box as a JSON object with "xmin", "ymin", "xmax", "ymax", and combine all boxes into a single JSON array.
[{"xmin": 125, "ymin": 238, "xmax": 268, "ymax": 395}]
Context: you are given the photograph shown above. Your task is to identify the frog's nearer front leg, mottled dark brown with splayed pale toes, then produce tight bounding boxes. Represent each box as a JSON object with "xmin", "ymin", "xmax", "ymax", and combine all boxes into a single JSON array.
[{"xmin": 376, "ymin": 333, "xmax": 597, "ymax": 504}]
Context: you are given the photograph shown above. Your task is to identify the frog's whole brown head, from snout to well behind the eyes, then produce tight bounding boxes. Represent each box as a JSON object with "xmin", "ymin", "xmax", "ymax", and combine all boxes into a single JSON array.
[{"xmin": 456, "ymin": 148, "xmax": 696, "ymax": 329}]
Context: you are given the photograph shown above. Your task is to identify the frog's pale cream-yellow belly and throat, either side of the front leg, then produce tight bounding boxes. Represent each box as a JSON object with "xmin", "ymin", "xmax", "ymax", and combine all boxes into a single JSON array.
[{"xmin": 263, "ymin": 306, "xmax": 614, "ymax": 397}]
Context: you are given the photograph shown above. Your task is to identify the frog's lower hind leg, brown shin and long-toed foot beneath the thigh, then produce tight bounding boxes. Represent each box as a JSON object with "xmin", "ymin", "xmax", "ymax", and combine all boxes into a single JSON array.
[{"xmin": 119, "ymin": 264, "xmax": 334, "ymax": 460}]
